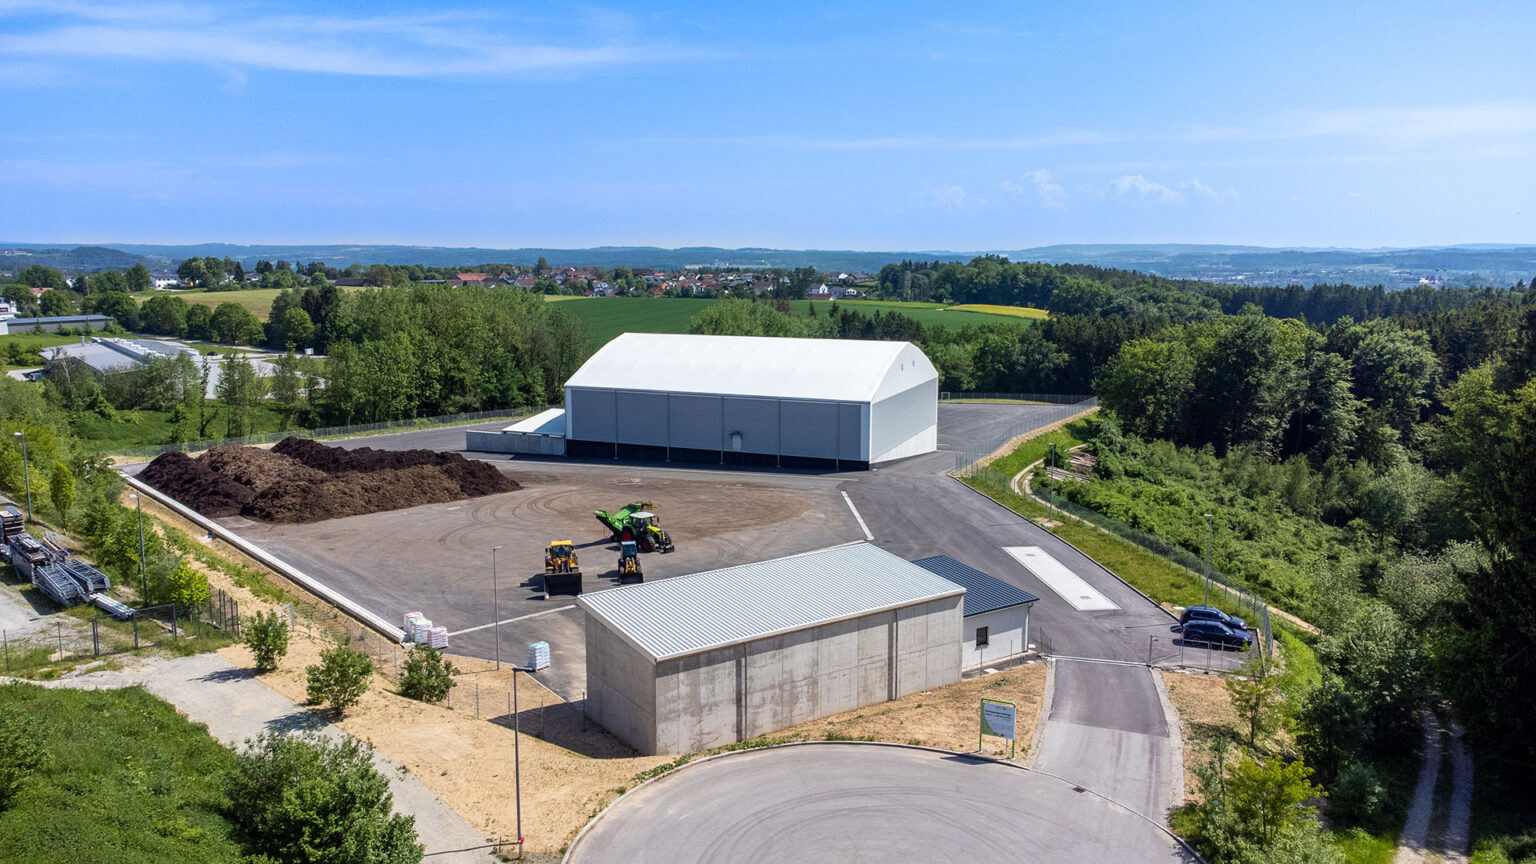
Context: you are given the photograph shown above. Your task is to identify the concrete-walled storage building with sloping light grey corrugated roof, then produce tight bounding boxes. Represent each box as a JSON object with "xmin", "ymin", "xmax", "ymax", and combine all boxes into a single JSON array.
[{"xmin": 578, "ymin": 544, "xmax": 965, "ymax": 753}]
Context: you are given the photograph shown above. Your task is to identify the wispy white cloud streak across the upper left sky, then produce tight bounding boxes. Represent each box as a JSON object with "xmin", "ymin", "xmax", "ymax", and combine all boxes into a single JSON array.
[{"xmin": 0, "ymin": 0, "xmax": 678, "ymax": 77}]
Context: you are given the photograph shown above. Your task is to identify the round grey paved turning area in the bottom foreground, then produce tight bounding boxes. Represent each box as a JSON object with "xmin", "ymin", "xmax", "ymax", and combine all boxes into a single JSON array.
[{"xmin": 567, "ymin": 744, "xmax": 1195, "ymax": 864}]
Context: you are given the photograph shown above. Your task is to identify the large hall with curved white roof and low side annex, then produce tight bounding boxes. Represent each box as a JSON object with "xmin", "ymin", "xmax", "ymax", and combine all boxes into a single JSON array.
[{"xmin": 467, "ymin": 334, "xmax": 938, "ymax": 470}]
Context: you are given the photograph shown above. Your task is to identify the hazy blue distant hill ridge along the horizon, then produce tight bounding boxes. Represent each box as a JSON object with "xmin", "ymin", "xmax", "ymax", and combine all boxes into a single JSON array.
[{"xmin": 0, "ymin": 243, "xmax": 1536, "ymax": 287}]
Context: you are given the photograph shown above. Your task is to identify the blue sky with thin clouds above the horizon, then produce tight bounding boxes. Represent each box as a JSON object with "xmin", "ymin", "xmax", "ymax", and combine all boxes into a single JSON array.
[{"xmin": 0, "ymin": 0, "xmax": 1536, "ymax": 251}]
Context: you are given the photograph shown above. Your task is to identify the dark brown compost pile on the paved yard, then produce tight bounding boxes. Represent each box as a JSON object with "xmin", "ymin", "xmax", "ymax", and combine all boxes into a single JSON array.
[{"xmin": 138, "ymin": 438, "xmax": 521, "ymax": 523}]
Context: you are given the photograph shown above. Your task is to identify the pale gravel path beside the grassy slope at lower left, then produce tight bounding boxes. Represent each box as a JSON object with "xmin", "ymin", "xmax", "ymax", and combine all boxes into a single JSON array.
[{"xmin": 13, "ymin": 653, "xmax": 495, "ymax": 864}]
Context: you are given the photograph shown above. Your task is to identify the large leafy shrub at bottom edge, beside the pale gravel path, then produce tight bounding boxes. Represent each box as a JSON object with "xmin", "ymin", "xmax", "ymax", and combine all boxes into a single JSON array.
[{"xmin": 224, "ymin": 728, "xmax": 424, "ymax": 864}]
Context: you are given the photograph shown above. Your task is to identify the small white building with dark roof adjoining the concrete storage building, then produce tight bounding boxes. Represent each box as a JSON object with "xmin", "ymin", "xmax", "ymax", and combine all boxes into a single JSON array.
[{"xmin": 912, "ymin": 555, "xmax": 1040, "ymax": 669}]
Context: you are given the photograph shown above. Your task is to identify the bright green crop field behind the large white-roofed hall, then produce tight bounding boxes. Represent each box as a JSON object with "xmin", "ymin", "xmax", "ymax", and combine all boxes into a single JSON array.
[{"xmin": 545, "ymin": 297, "xmax": 1028, "ymax": 347}]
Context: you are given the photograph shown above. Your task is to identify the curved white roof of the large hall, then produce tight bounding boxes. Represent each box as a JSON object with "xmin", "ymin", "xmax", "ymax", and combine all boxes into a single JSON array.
[{"xmin": 565, "ymin": 334, "xmax": 938, "ymax": 401}]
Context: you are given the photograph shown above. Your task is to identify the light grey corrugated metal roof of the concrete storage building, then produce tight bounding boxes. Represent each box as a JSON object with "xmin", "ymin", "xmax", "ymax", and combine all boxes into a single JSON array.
[{"xmin": 578, "ymin": 543, "xmax": 963, "ymax": 661}]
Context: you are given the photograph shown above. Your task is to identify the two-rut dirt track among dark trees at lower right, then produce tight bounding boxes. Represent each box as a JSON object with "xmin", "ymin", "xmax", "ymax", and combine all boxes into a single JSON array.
[{"xmin": 1393, "ymin": 707, "xmax": 1471, "ymax": 864}]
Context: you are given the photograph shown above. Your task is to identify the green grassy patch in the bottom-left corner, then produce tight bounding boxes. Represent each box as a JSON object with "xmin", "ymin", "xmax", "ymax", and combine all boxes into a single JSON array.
[{"xmin": 0, "ymin": 684, "xmax": 243, "ymax": 864}]
